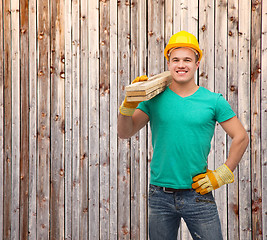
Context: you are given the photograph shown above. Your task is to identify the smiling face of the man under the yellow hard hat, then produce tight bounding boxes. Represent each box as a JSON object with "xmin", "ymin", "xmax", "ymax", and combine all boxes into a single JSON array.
[{"xmin": 168, "ymin": 48, "xmax": 199, "ymax": 84}]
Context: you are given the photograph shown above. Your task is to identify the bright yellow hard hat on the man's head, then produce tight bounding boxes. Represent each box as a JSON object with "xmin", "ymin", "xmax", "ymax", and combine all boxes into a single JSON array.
[{"xmin": 164, "ymin": 31, "xmax": 202, "ymax": 61}]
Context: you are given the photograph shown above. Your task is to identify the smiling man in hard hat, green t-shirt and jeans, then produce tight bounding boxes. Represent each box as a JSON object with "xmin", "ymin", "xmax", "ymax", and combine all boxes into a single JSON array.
[{"xmin": 118, "ymin": 31, "xmax": 248, "ymax": 240}]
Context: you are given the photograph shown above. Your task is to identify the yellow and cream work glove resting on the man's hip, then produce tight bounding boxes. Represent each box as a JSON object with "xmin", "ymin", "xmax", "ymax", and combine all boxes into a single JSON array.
[{"xmin": 192, "ymin": 164, "xmax": 234, "ymax": 195}]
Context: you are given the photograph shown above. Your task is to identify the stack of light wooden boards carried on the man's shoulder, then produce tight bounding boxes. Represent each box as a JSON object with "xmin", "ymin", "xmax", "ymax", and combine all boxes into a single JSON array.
[{"xmin": 126, "ymin": 71, "xmax": 172, "ymax": 102}]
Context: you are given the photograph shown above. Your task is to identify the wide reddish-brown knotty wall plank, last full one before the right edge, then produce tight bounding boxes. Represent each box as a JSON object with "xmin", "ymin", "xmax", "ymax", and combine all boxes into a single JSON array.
[{"xmin": 251, "ymin": 0, "xmax": 262, "ymax": 239}]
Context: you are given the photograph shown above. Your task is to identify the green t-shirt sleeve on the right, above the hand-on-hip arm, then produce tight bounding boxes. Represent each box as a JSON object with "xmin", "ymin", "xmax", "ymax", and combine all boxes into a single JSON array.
[{"xmin": 215, "ymin": 94, "xmax": 236, "ymax": 123}]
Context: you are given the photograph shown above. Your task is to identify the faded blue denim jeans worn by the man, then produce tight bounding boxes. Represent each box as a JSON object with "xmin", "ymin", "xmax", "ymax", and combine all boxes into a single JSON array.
[{"xmin": 148, "ymin": 185, "xmax": 223, "ymax": 240}]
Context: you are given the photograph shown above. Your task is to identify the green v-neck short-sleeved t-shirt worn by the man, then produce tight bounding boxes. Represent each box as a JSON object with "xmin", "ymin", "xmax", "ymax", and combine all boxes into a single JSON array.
[{"xmin": 138, "ymin": 87, "xmax": 235, "ymax": 189}]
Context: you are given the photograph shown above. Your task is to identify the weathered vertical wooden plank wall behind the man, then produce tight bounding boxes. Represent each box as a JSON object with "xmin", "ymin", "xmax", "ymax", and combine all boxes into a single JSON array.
[{"xmin": 0, "ymin": 0, "xmax": 267, "ymax": 240}]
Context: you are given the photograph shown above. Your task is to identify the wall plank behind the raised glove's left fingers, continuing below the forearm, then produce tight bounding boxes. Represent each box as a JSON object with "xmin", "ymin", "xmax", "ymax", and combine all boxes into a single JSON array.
[{"xmin": 130, "ymin": 0, "xmax": 140, "ymax": 239}]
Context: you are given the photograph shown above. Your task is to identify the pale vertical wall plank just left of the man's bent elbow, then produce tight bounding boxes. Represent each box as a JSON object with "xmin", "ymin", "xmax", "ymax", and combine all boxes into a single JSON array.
[{"xmin": 109, "ymin": 0, "xmax": 118, "ymax": 240}]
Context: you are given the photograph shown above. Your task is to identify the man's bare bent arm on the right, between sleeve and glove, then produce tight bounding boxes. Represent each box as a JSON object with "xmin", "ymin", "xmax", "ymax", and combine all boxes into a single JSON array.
[{"xmin": 220, "ymin": 117, "xmax": 249, "ymax": 172}]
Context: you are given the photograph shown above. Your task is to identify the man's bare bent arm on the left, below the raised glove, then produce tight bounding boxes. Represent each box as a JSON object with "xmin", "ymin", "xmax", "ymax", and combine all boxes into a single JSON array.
[{"xmin": 118, "ymin": 109, "xmax": 149, "ymax": 138}]
